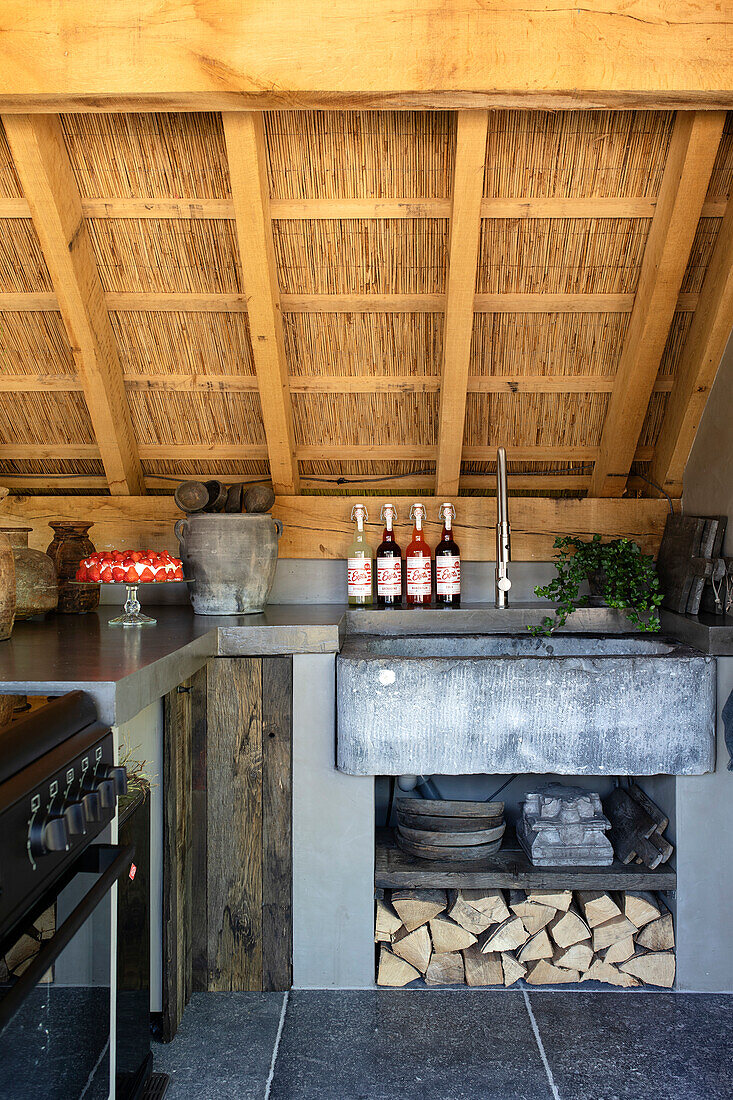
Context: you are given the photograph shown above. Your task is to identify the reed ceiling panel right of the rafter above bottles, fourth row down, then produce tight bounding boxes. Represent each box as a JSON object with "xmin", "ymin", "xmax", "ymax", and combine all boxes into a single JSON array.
[{"xmin": 463, "ymin": 394, "xmax": 609, "ymax": 447}]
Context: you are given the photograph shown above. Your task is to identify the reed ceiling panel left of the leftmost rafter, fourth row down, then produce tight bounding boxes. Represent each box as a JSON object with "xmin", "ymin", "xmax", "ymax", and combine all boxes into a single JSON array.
[{"xmin": 0, "ymin": 393, "xmax": 95, "ymax": 448}]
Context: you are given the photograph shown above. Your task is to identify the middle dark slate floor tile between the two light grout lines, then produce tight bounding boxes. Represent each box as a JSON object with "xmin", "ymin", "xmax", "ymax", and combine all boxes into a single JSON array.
[{"xmin": 270, "ymin": 989, "xmax": 553, "ymax": 1100}]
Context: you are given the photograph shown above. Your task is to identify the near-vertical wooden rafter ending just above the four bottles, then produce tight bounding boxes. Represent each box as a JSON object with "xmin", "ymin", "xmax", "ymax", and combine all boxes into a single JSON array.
[{"xmin": 435, "ymin": 111, "xmax": 489, "ymax": 496}]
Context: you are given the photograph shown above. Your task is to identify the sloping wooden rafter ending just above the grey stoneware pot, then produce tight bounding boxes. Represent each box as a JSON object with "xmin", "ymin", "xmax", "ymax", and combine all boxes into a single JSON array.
[{"xmin": 222, "ymin": 113, "xmax": 298, "ymax": 493}]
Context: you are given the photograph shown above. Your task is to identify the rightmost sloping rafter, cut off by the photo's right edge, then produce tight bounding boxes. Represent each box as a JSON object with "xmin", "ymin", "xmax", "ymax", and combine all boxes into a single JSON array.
[{"xmin": 649, "ymin": 202, "xmax": 733, "ymax": 496}]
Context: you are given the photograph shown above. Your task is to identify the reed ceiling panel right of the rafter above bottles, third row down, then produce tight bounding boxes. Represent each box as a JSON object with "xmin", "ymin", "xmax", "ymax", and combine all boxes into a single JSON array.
[{"xmin": 470, "ymin": 314, "xmax": 628, "ymax": 378}]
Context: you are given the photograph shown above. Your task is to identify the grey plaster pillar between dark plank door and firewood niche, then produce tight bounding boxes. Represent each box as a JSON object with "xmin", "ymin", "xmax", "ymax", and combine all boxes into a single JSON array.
[{"xmin": 293, "ymin": 653, "xmax": 374, "ymax": 989}]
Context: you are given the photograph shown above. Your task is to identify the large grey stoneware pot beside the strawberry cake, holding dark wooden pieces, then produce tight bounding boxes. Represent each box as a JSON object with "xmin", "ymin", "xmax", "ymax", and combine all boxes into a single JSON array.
[{"xmin": 175, "ymin": 513, "xmax": 283, "ymax": 615}]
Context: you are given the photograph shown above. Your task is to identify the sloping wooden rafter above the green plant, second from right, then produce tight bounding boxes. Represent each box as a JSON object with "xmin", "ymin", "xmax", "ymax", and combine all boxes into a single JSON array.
[{"xmin": 589, "ymin": 111, "xmax": 725, "ymax": 496}]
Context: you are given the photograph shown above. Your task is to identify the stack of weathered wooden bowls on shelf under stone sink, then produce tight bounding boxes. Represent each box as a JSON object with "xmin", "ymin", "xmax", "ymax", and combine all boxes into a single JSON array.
[{"xmin": 396, "ymin": 799, "xmax": 506, "ymax": 862}]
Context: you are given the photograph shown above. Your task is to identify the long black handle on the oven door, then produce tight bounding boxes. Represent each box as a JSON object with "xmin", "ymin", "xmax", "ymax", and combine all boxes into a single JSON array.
[{"xmin": 0, "ymin": 845, "xmax": 134, "ymax": 1031}]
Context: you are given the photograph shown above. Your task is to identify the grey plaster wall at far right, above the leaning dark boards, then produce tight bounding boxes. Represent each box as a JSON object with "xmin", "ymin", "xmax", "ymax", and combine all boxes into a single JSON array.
[{"xmin": 682, "ymin": 337, "xmax": 733, "ymax": 554}]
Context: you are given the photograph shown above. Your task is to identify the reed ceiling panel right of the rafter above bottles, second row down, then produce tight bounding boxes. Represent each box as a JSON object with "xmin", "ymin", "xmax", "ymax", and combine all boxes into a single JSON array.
[{"xmin": 477, "ymin": 218, "xmax": 650, "ymax": 294}]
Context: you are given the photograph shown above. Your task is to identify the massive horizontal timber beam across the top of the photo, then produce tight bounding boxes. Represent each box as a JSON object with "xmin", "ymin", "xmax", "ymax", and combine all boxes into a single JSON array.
[{"xmin": 0, "ymin": 0, "xmax": 733, "ymax": 111}]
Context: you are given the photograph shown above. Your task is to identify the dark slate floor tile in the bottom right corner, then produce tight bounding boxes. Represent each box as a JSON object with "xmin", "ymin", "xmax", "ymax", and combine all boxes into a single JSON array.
[{"xmin": 529, "ymin": 992, "xmax": 733, "ymax": 1100}]
